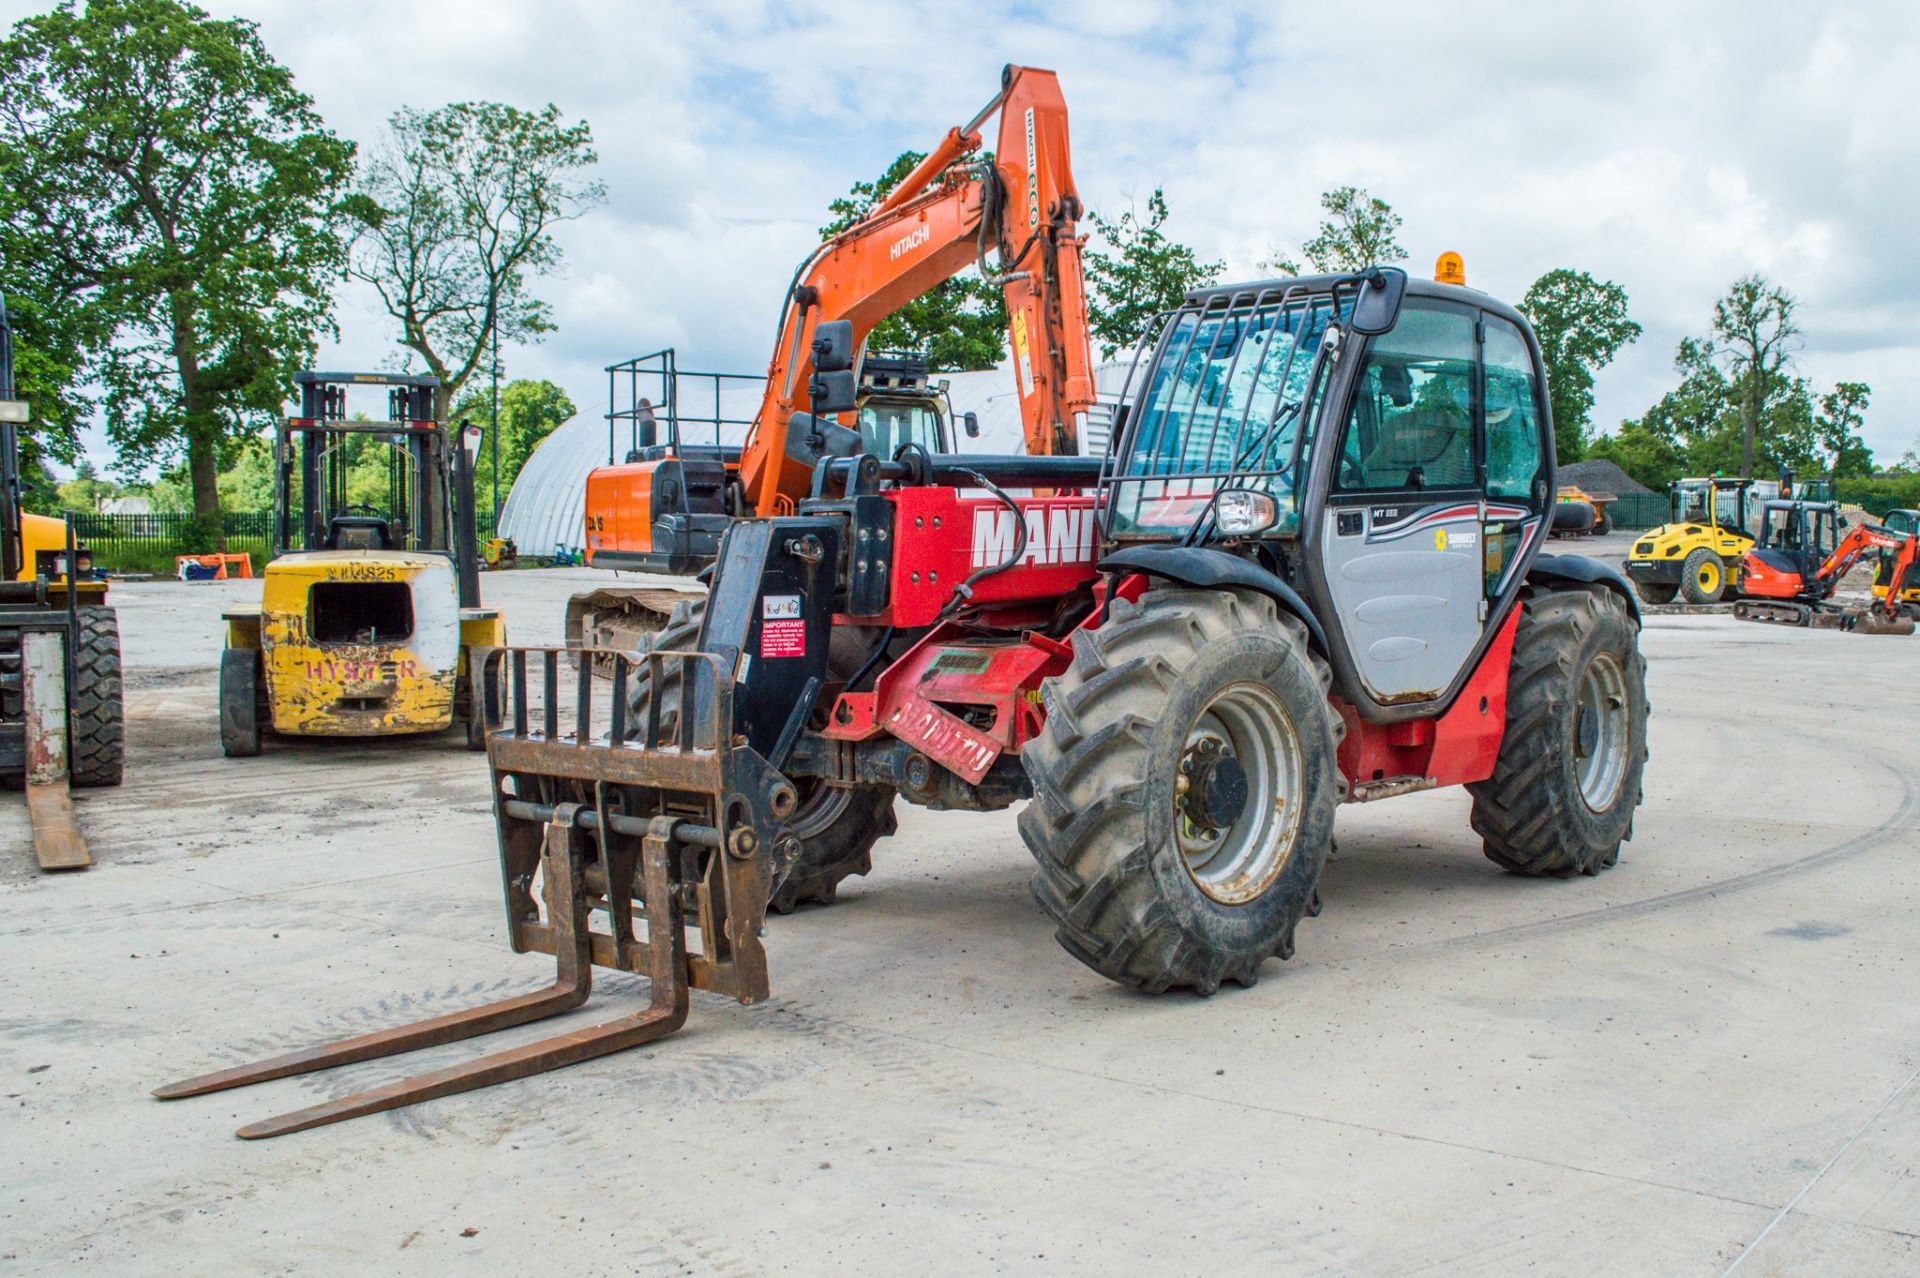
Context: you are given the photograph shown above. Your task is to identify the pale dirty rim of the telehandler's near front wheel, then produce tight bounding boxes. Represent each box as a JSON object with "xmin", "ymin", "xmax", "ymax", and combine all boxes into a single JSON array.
[{"xmin": 1173, "ymin": 683, "xmax": 1306, "ymax": 906}]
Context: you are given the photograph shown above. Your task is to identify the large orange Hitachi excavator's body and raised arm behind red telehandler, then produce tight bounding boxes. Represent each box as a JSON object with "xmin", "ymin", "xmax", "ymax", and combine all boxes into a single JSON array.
[{"xmin": 584, "ymin": 67, "xmax": 1094, "ymax": 597}]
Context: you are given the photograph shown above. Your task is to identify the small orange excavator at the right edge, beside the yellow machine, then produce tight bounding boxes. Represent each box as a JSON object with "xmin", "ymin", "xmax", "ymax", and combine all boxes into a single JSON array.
[{"xmin": 1734, "ymin": 501, "xmax": 1920, "ymax": 635}]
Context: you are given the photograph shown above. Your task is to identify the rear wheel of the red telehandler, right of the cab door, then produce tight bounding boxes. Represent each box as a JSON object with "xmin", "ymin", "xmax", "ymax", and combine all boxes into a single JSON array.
[{"xmin": 1467, "ymin": 589, "xmax": 1647, "ymax": 879}]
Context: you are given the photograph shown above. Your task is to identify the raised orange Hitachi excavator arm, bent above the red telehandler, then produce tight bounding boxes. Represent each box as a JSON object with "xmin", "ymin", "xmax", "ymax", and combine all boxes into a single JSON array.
[{"xmin": 741, "ymin": 67, "xmax": 1092, "ymax": 514}]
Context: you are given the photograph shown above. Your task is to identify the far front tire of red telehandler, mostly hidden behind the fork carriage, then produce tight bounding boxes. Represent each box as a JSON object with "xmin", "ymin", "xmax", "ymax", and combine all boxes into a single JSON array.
[{"xmin": 626, "ymin": 597, "xmax": 897, "ymax": 913}]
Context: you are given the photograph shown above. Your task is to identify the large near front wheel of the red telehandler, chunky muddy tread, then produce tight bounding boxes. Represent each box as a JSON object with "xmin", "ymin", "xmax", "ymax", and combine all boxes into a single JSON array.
[{"xmin": 1020, "ymin": 587, "xmax": 1346, "ymax": 994}]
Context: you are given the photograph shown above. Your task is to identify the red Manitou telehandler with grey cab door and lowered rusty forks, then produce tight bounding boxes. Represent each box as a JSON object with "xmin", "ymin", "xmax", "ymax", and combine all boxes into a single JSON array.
[{"xmin": 157, "ymin": 71, "xmax": 1647, "ymax": 1138}]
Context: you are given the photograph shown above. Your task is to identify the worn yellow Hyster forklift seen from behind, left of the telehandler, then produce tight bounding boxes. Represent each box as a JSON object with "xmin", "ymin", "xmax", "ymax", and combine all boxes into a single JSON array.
[{"xmin": 221, "ymin": 372, "xmax": 507, "ymax": 756}]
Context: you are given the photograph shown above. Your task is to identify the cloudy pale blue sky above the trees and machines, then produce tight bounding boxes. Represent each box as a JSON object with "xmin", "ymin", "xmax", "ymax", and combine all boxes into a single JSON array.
[{"xmin": 15, "ymin": 0, "xmax": 1920, "ymax": 461}]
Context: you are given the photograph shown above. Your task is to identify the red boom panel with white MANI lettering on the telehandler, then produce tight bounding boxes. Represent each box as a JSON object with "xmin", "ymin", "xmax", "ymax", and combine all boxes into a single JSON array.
[{"xmin": 879, "ymin": 487, "xmax": 1100, "ymax": 626}]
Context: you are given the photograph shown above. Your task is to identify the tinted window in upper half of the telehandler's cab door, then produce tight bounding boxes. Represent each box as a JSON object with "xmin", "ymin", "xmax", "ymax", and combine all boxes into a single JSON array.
[{"xmin": 1334, "ymin": 299, "xmax": 1475, "ymax": 491}]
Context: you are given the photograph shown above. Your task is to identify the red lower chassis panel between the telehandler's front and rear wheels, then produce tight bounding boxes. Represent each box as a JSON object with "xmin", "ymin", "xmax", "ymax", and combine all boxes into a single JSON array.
[{"xmin": 1332, "ymin": 608, "xmax": 1521, "ymax": 785}]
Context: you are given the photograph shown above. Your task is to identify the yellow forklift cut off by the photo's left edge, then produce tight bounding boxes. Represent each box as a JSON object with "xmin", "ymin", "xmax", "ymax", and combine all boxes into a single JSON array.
[{"xmin": 0, "ymin": 297, "xmax": 125, "ymax": 869}]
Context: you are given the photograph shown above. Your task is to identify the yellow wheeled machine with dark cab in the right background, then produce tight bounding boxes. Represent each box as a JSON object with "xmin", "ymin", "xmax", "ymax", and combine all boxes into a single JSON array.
[{"xmin": 1626, "ymin": 476, "xmax": 1791, "ymax": 604}]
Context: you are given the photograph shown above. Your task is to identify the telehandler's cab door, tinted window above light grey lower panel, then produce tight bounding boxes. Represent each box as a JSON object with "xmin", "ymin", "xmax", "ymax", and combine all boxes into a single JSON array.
[{"xmin": 1319, "ymin": 297, "xmax": 1486, "ymax": 704}]
